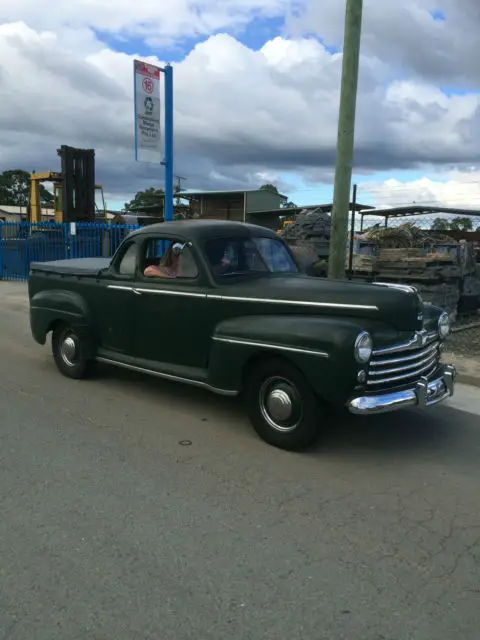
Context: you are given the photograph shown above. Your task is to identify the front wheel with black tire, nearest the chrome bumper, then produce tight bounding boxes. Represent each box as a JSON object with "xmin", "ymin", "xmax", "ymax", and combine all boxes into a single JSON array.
[{"xmin": 245, "ymin": 358, "xmax": 322, "ymax": 451}]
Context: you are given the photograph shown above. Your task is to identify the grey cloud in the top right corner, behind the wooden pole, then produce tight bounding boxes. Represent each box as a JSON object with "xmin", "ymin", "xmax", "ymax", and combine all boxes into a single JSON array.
[{"xmin": 289, "ymin": 0, "xmax": 480, "ymax": 89}]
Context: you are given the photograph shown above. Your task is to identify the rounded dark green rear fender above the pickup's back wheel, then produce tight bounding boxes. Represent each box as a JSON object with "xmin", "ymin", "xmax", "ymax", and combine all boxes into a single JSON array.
[{"xmin": 30, "ymin": 289, "xmax": 92, "ymax": 344}]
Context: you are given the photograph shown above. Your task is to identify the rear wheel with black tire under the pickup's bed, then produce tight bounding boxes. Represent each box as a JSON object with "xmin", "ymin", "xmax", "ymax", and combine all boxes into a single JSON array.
[{"xmin": 52, "ymin": 324, "xmax": 93, "ymax": 380}]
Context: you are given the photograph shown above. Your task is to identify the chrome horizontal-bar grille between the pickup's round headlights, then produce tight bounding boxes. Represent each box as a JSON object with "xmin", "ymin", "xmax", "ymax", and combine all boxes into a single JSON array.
[{"xmin": 367, "ymin": 334, "xmax": 440, "ymax": 389}]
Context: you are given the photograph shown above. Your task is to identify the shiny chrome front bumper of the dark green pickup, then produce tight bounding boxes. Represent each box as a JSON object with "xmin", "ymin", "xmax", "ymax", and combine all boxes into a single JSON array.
[{"xmin": 347, "ymin": 364, "xmax": 457, "ymax": 415}]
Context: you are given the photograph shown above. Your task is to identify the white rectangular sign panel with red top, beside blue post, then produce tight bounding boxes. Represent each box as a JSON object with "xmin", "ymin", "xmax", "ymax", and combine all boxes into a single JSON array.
[{"xmin": 133, "ymin": 60, "xmax": 163, "ymax": 164}]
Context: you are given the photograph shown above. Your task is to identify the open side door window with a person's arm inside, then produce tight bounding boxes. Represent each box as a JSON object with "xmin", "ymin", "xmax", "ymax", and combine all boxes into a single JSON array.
[{"xmin": 140, "ymin": 237, "xmax": 198, "ymax": 280}]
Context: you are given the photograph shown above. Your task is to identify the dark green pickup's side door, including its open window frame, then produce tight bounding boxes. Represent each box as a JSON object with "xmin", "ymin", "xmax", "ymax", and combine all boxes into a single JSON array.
[{"xmin": 135, "ymin": 235, "xmax": 209, "ymax": 369}]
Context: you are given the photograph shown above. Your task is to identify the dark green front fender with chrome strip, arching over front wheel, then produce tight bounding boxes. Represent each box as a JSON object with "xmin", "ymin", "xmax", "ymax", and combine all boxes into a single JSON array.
[{"xmin": 209, "ymin": 315, "xmax": 362, "ymax": 402}]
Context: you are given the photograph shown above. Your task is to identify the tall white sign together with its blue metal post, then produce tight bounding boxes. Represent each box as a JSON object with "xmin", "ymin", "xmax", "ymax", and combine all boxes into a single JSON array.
[{"xmin": 133, "ymin": 60, "xmax": 173, "ymax": 220}]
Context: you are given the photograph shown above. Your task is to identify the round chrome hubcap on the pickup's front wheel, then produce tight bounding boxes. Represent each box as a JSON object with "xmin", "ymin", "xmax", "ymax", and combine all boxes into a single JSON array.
[{"xmin": 259, "ymin": 378, "xmax": 302, "ymax": 432}]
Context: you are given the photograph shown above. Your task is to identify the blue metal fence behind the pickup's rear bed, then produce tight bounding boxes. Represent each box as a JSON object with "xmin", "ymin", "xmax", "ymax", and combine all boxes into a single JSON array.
[{"xmin": 0, "ymin": 222, "xmax": 139, "ymax": 280}]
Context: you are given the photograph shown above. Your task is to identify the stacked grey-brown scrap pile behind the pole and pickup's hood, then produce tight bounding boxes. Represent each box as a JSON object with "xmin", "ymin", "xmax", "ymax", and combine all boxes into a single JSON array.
[{"xmin": 280, "ymin": 218, "xmax": 480, "ymax": 320}]
